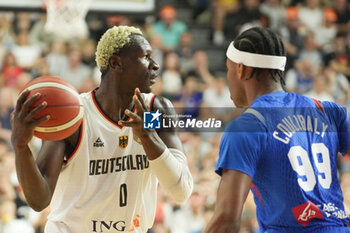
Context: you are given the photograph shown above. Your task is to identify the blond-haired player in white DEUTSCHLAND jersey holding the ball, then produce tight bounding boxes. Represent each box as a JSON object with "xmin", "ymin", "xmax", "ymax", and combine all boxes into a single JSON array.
[{"xmin": 12, "ymin": 26, "xmax": 193, "ymax": 233}]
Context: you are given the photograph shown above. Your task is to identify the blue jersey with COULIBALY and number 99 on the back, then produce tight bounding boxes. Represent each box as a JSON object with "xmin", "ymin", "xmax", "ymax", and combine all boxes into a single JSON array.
[{"xmin": 216, "ymin": 91, "xmax": 350, "ymax": 233}]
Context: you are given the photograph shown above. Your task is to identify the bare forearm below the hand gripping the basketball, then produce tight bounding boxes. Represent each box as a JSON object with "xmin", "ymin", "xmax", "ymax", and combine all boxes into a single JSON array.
[{"xmin": 14, "ymin": 146, "xmax": 52, "ymax": 211}]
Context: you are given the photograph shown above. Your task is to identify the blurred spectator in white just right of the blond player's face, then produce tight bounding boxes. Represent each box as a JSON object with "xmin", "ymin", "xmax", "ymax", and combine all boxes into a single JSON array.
[{"xmin": 161, "ymin": 52, "xmax": 182, "ymax": 99}]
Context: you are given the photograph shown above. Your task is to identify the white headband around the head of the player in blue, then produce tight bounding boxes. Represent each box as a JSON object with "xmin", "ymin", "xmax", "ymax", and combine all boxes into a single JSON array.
[{"xmin": 226, "ymin": 42, "xmax": 287, "ymax": 71}]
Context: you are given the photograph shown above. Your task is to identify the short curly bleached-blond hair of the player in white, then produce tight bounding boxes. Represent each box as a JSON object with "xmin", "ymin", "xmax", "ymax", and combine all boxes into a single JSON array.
[{"xmin": 95, "ymin": 26, "xmax": 142, "ymax": 71}]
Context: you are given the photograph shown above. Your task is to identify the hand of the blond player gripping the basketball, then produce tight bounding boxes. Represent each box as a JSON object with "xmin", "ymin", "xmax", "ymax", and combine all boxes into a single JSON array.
[{"xmin": 11, "ymin": 90, "xmax": 50, "ymax": 148}]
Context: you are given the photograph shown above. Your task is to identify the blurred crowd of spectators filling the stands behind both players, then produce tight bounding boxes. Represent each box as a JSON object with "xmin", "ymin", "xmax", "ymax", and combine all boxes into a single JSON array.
[{"xmin": 0, "ymin": 0, "xmax": 350, "ymax": 233}]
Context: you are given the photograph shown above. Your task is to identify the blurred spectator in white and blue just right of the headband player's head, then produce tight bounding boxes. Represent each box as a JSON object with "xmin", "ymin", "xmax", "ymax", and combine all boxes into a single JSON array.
[{"xmin": 286, "ymin": 59, "xmax": 316, "ymax": 94}]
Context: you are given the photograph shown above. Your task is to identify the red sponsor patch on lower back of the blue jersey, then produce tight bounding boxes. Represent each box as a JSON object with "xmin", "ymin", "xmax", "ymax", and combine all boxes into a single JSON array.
[{"xmin": 292, "ymin": 201, "xmax": 323, "ymax": 227}]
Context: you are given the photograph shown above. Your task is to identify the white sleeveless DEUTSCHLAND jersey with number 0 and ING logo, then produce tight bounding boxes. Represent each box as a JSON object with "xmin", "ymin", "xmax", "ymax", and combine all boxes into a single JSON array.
[{"xmin": 45, "ymin": 92, "xmax": 158, "ymax": 233}]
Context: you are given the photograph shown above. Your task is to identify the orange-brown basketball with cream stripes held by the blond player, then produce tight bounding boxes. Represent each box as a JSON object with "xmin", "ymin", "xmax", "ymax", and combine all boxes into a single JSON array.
[{"xmin": 23, "ymin": 76, "xmax": 83, "ymax": 141}]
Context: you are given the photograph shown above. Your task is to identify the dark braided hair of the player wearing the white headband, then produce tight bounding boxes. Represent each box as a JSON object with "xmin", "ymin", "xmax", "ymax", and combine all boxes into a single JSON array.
[{"xmin": 234, "ymin": 27, "xmax": 286, "ymax": 87}]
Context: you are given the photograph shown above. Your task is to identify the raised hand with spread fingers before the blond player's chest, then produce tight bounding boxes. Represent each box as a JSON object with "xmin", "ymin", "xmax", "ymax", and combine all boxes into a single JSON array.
[{"xmin": 118, "ymin": 88, "xmax": 155, "ymax": 139}]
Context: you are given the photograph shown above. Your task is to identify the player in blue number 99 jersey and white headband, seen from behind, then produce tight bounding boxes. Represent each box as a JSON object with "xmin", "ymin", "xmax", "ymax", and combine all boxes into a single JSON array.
[{"xmin": 205, "ymin": 27, "xmax": 350, "ymax": 233}]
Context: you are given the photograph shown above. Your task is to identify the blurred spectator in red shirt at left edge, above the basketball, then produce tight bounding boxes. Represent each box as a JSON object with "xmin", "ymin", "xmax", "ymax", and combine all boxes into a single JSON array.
[{"xmin": 0, "ymin": 53, "xmax": 23, "ymax": 87}]
